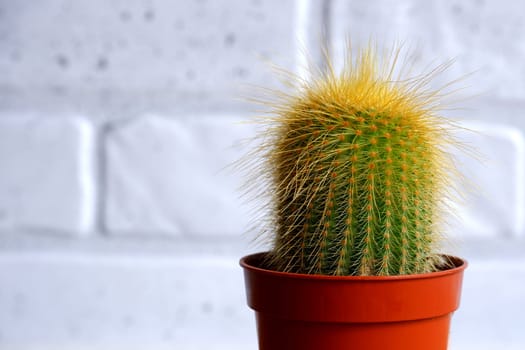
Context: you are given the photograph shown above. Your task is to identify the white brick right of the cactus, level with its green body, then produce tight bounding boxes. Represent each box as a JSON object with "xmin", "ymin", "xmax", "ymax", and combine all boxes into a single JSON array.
[{"xmin": 446, "ymin": 121, "xmax": 525, "ymax": 237}]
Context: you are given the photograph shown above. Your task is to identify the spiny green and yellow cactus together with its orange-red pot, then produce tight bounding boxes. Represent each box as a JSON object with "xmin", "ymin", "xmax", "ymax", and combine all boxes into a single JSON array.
[{"xmin": 241, "ymin": 44, "xmax": 467, "ymax": 350}]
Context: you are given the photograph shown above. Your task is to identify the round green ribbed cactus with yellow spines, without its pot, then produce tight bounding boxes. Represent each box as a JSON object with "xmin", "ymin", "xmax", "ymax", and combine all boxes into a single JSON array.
[{"xmin": 255, "ymin": 47, "xmax": 453, "ymax": 276}]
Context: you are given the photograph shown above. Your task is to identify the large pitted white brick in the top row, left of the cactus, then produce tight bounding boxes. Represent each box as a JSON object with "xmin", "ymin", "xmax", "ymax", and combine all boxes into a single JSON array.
[{"xmin": 0, "ymin": 0, "xmax": 320, "ymax": 110}]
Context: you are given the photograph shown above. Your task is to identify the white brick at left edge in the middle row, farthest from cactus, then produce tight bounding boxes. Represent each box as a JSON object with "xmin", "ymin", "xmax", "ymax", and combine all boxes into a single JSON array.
[{"xmin": 0, "ymin": 115, "xmax": 95, "ymax": 235}]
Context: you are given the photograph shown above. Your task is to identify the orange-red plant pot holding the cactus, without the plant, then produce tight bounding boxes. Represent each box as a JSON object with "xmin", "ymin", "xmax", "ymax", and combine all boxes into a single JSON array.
[{"xmin": 240, "ymin": 253, "xmax": 467, "ymax": 350}]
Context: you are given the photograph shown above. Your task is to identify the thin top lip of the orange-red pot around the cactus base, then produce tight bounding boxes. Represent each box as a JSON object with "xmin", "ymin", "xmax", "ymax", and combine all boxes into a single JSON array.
[{"xmin": 239, "ymin": 252, "xmax": 468, "ymax": 282}]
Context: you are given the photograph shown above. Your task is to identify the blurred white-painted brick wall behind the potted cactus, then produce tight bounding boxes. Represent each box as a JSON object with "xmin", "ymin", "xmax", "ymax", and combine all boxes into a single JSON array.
[{"xmin": 0, "ymin": 0, "xmax": 525, "ymax": 350}]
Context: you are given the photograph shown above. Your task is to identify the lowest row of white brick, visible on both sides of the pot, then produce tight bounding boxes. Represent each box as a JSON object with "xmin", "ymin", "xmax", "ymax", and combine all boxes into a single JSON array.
[{"xmin": 0, "ymin": 246, "xmax": 525, "ymax": 350}]
